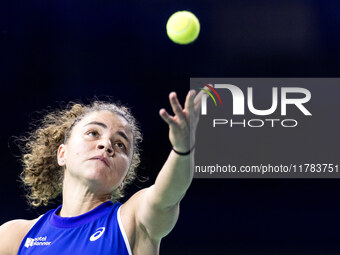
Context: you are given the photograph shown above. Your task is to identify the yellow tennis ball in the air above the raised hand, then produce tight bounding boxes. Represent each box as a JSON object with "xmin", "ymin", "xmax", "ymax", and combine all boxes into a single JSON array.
[{"xmin": 166, "ymin": 11, "xmax": 200, "ymax": 44}]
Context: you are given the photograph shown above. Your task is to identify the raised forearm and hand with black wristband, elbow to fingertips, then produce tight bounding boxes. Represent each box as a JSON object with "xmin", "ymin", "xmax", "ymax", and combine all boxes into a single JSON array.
[{"xmin": 149, "ymin": 90, "xmax": 200, "ymax": 209}]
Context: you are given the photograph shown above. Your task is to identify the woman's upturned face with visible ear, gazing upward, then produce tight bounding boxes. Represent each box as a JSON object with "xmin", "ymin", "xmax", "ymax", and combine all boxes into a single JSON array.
[{"xmin": 58, "ymin": 111, "xmax": 133, "ymax": 194}]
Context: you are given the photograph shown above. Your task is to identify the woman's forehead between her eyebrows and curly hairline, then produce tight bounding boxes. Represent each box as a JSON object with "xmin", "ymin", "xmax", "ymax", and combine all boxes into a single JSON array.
[{"xmin": 77, "ymin": 110, "xmax": 132, "ymax": 133}]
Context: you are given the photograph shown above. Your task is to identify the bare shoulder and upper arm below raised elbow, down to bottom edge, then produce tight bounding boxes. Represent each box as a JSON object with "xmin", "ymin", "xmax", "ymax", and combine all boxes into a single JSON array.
[{"xmin": 120, "ymin": 185, "xmax": 179, "ymax": 255}]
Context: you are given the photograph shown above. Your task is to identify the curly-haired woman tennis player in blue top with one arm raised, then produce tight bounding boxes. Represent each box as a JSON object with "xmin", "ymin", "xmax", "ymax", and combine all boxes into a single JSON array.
[{"xmin": 0, "ymin": 90, "xmax": 202, "ymax": 255}]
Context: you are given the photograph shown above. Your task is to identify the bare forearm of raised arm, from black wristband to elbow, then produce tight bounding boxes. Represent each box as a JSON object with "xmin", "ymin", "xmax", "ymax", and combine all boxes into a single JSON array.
[{"xmin": 153, "ymin": 151, "xmax": 194, "ymax": 208}]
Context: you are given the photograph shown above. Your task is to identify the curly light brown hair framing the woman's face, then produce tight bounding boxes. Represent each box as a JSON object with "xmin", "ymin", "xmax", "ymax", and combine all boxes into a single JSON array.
[{"xmin": 19, "ymin": 101, "xmax": 142, "ymax": 207}]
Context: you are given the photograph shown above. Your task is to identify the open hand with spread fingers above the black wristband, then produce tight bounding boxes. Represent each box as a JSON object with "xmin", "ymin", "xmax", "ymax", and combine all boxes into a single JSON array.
[{"xmin": 159, "ymin": 90, "xmax": 205, "ymax": 152}]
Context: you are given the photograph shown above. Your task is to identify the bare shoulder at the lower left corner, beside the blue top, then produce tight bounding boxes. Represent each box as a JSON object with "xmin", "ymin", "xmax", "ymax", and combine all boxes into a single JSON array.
[{"xmin": 0, "ymin": 218, "xmax": 38, "ymax": 255}]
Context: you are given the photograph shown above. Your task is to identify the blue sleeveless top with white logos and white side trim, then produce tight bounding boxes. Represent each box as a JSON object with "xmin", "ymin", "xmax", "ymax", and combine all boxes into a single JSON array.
[{"xmin": 18, "ymin": 201, "xmax": 132, "ymax": 255}]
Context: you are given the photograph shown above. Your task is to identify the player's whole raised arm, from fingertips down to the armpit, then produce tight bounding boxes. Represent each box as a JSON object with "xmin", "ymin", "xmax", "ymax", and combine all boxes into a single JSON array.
[{"xmin": 125, "ymin": 90, "xmax": 203, "ymax": 243}]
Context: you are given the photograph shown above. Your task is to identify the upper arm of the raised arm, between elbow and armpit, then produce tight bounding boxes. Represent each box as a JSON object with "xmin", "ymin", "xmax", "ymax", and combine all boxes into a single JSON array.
[{"xmin": 126, "ymin": 185, "xmax": 179, "ymax": 241}]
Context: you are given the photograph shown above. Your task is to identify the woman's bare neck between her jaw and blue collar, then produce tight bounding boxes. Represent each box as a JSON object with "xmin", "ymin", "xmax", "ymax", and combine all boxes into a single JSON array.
[{"xmin": 59, "ymin": 171, "xmax": 111, "ymax": 217}]
